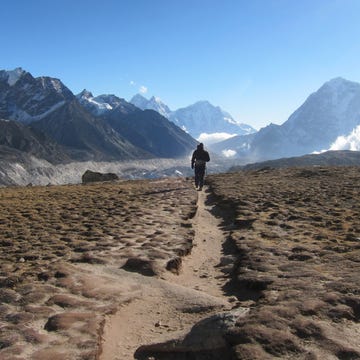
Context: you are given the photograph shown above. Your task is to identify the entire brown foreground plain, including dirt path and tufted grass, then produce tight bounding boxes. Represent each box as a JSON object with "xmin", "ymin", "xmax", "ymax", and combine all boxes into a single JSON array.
[{"xmin": 0, "ymin": 167, "xmax": 360, "ymax": 360}]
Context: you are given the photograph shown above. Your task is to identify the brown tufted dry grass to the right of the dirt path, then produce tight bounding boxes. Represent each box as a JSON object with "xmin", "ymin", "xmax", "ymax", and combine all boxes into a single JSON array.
[{"xmin": 208, "ymin": 168, "xmax": 360, "ymax": 359}]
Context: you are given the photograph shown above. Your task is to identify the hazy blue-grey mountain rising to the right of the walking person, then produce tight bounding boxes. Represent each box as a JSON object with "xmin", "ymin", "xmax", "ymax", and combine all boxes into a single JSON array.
[{"xmin": 212, "ymin": 78, "xmax": 360, "ymax": 163}]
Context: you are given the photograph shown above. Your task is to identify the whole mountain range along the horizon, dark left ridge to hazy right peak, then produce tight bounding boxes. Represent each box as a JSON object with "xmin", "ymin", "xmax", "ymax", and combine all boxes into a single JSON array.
[{"xmin": 0, "ymin": 68, "xmax": 360, "ymax": 184}]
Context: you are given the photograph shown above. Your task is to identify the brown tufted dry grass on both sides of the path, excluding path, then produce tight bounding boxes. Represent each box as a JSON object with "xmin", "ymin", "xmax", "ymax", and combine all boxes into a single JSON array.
[{"xmin": 0, "ymin": 167, "xmax": 360, "ymax": 360}]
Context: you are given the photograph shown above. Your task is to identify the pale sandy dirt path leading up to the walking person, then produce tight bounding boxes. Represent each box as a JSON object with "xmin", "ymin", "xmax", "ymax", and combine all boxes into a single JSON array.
[{"xmin": 100, "ymin": 189, "xmax": 230, "ymax": 360}]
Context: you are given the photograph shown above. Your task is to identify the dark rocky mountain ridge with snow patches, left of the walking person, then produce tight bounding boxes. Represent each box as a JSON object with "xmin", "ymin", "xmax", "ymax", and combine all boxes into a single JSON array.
[{"xmin": 0, "ymin": 69, "xmax": 196, "ymax": 163}]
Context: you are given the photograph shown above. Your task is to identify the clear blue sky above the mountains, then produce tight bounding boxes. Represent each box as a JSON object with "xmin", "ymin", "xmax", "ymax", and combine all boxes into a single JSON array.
[{"xmin": 0, "ymin": 0, "xmax": 360, "ymax": 129}]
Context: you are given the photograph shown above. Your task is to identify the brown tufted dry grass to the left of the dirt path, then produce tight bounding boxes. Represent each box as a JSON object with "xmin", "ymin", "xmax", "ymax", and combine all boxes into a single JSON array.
[{"xmin": 0, "ymin": 179, "xmax": 196, "ymax": 359}]
